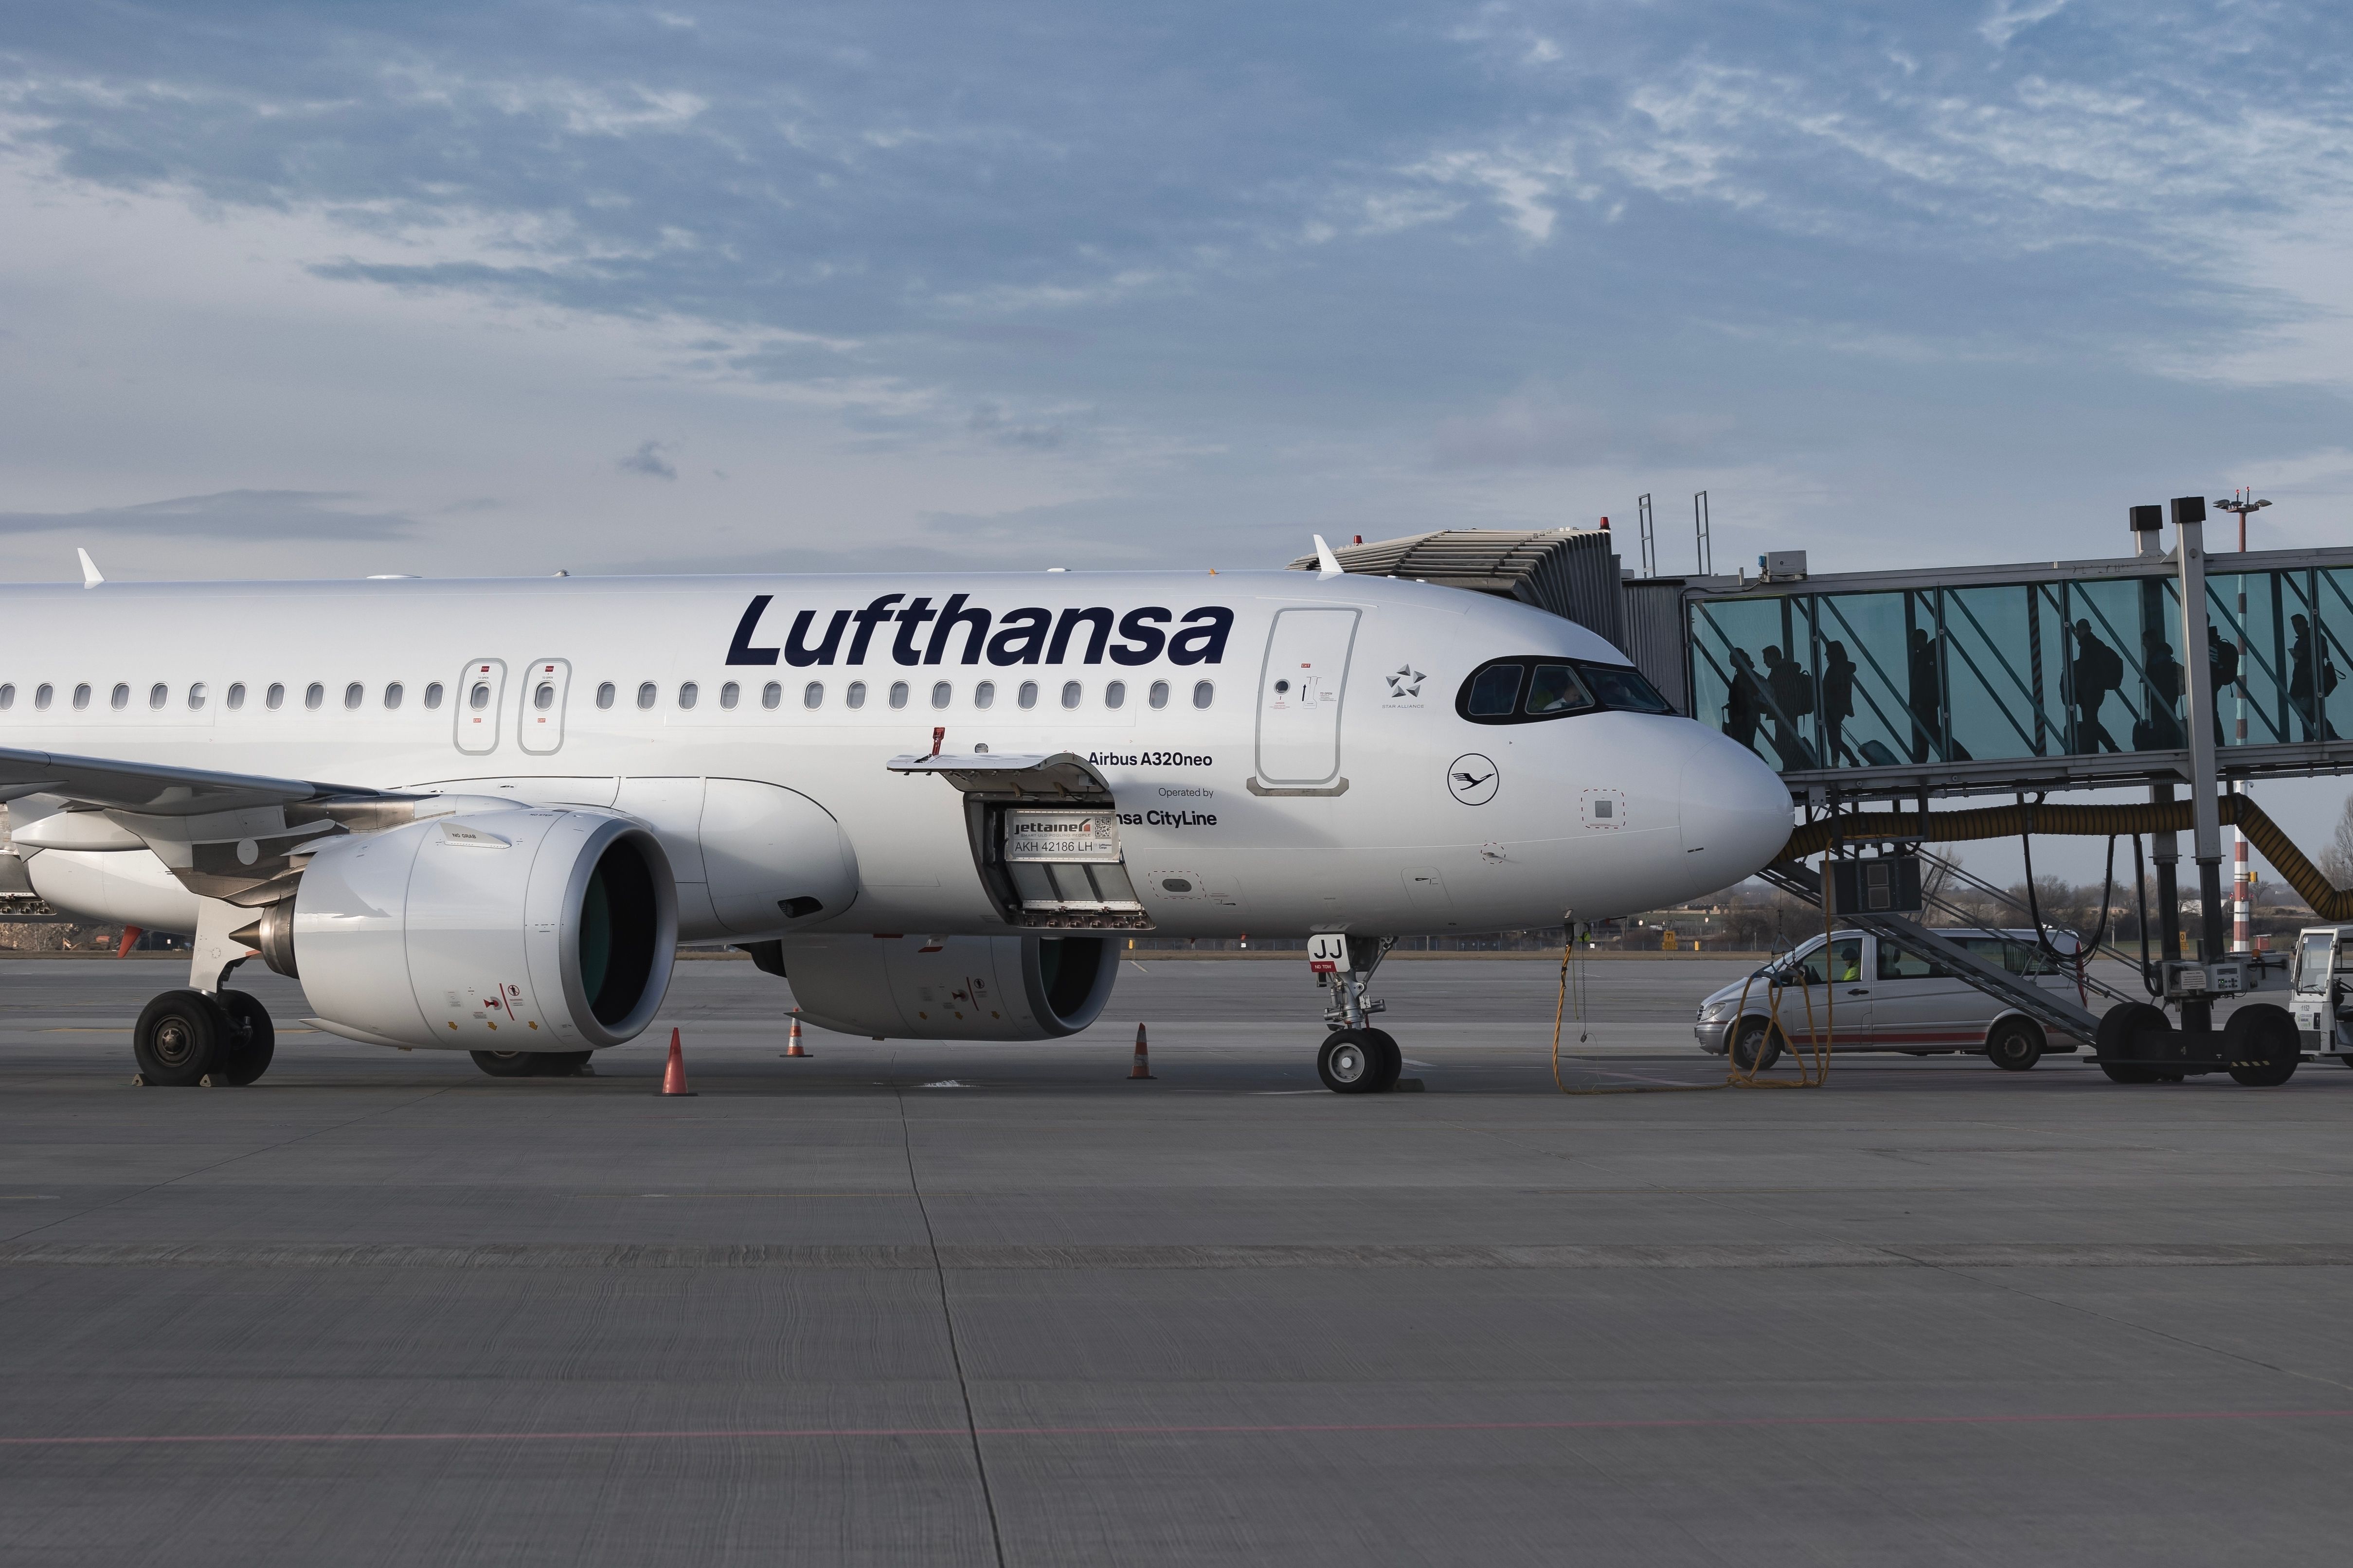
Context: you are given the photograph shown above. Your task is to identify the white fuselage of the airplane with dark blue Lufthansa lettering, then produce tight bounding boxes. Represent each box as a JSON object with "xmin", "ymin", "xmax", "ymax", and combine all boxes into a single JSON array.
[{"xmin": 0, "ymin": 571, "xmax": 1788, "ymax": 940}]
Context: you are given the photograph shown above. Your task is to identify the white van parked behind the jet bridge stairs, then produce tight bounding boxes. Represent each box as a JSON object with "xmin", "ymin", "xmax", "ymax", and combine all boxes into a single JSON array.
[{"xmin": 1694, "ymin": 926, "xmax": 2087, "ymax": 1072}]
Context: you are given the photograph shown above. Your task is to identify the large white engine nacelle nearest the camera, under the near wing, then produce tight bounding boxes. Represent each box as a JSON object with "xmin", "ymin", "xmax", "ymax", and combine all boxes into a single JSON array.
[{"xmin": 259, "ymin": 811, "xmax": 678, "ymax": 1051}]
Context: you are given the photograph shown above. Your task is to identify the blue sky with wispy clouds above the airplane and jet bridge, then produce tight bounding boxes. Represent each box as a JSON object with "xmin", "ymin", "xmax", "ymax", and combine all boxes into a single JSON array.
[{"xmin": 0, "ymin": 0, "xmax": 2353, "ymax": 578}]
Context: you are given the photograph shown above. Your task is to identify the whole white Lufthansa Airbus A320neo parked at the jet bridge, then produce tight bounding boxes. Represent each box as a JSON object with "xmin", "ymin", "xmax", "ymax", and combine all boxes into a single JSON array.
[{"xmin": 0, "ymin": 541, "xmax": 1791, "ymax": 1093}]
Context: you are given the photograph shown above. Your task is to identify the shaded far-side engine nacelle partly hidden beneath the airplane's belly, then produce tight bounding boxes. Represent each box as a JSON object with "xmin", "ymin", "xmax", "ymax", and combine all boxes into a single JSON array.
[{"xmin": 776, "ymin": 936, "xmax": 1120, "ymax": 1039}]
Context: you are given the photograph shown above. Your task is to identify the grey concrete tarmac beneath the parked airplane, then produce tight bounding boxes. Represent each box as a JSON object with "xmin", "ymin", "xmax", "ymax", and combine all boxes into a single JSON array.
[{"xmin": 0, "ymin": 959, "xmax": 2353, "ymax": 1568}]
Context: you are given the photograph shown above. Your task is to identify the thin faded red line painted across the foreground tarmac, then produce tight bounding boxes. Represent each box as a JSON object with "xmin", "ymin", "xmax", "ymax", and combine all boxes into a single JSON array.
[{"xmin": 0, "ymin": 1410, "xmax": 2353, "ymax": 1448}]
